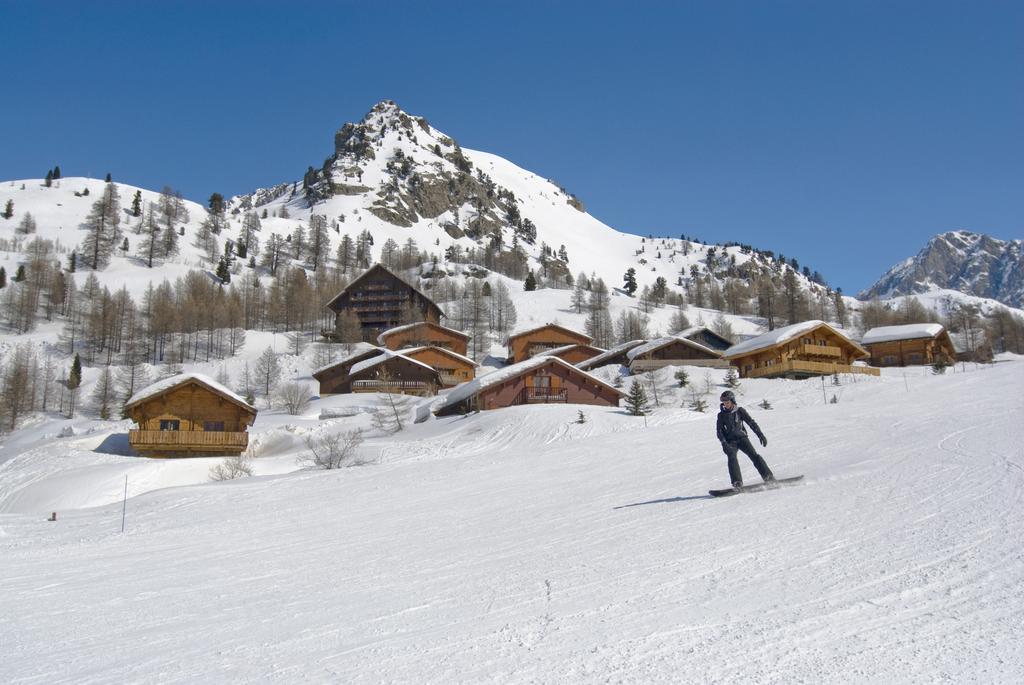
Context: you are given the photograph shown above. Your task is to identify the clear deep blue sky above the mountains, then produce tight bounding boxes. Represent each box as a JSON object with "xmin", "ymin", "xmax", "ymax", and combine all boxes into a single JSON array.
[{"xmin": 0, "ymin": 0, "xmax": 1024, "ymax": 294}]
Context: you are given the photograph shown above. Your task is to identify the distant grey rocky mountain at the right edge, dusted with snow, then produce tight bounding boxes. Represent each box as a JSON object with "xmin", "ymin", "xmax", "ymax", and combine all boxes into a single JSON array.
[{"xmin": 860, "ymin": 230, "xmax": 1024, "ymax": 308}]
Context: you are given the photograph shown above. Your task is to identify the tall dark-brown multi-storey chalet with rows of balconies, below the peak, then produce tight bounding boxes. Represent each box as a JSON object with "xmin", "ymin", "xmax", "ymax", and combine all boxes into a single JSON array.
[{"xmin": 324, "ymin": 264, "xmax": 442, "ymax": 341}]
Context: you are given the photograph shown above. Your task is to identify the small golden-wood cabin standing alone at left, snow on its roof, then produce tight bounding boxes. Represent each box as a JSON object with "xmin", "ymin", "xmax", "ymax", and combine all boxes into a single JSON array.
[{"xmin": 125, "ymin": 374, "xmax": 256, "ymax": 457}]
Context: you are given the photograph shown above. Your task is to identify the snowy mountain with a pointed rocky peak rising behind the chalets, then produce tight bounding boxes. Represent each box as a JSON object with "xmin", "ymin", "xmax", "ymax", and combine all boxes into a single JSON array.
[{"xmin": 0, "ymin": 101, "xmax": 823, "ymax": 307}]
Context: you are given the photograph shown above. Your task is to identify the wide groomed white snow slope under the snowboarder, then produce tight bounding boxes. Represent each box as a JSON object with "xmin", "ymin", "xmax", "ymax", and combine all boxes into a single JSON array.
[{"xmin": 0, "ymin": 359, "xmax": 1024, "ymax": 683}]
